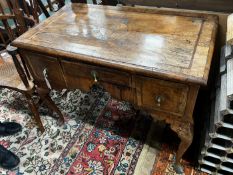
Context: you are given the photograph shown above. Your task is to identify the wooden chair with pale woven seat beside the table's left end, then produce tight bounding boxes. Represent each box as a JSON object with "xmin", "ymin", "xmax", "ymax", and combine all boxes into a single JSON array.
[{"xmin": 0, "ymin": 45, "xmax": 64, "ymax": 132}]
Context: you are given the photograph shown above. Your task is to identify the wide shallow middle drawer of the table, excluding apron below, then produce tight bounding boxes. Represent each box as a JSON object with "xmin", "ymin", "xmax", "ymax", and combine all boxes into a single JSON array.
[{"xmin": 61, "ymin": 60, "xmax": 131, "ymax": 87}]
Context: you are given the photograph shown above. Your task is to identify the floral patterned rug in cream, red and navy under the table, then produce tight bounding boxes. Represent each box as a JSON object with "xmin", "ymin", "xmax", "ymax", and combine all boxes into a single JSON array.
[{"xmin": 0, "ymin": 87, "xmax": 206, "ymax": 175}]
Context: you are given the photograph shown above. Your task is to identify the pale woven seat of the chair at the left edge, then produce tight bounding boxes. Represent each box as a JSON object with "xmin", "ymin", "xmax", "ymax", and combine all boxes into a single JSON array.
[{"xmin": 0, "ymin": 62, "xmax": 33, "ymax": 91}]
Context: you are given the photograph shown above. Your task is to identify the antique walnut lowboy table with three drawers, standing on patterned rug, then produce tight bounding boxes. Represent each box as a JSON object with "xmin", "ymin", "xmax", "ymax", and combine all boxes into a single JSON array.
[{"xmin": 13, "ymin": 4, "xmax": 218, "ymax": 172}]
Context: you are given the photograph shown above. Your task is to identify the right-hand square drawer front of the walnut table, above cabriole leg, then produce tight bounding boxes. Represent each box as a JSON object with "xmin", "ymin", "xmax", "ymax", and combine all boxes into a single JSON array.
[{"xmin": 136, "ymin": 77, "xmax": 188, "ymax": 116}]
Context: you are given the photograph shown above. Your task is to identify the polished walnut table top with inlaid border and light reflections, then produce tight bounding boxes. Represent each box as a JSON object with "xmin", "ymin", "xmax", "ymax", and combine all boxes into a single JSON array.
[{"xmin": 13, "ymin": 4, "xmax": 217, "ymax": 84}]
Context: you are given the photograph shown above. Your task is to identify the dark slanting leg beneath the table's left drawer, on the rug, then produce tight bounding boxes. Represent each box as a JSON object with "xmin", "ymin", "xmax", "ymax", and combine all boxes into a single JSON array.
[{"xmin": 37, "ymin": 88, "xmax": 65, "ymax": 125}]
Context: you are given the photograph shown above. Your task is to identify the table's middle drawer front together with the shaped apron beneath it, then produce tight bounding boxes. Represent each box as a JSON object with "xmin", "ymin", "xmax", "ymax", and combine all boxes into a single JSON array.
[{"xmin": 61, "ymin": 60, "xmax": 134, "ymax": 102}]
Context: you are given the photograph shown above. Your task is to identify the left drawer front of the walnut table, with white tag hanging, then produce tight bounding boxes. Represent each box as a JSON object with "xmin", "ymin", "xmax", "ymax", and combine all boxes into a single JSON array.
[{"xmin": 22, "ymin": 51, "xmax": 66, "ymax": 89}]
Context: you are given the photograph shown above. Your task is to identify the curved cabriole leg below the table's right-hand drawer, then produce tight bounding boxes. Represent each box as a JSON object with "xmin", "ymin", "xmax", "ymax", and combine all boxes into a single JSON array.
[{"xmin": 171, "ymin": 122, "xmax": 193, "ymax": 174}]
